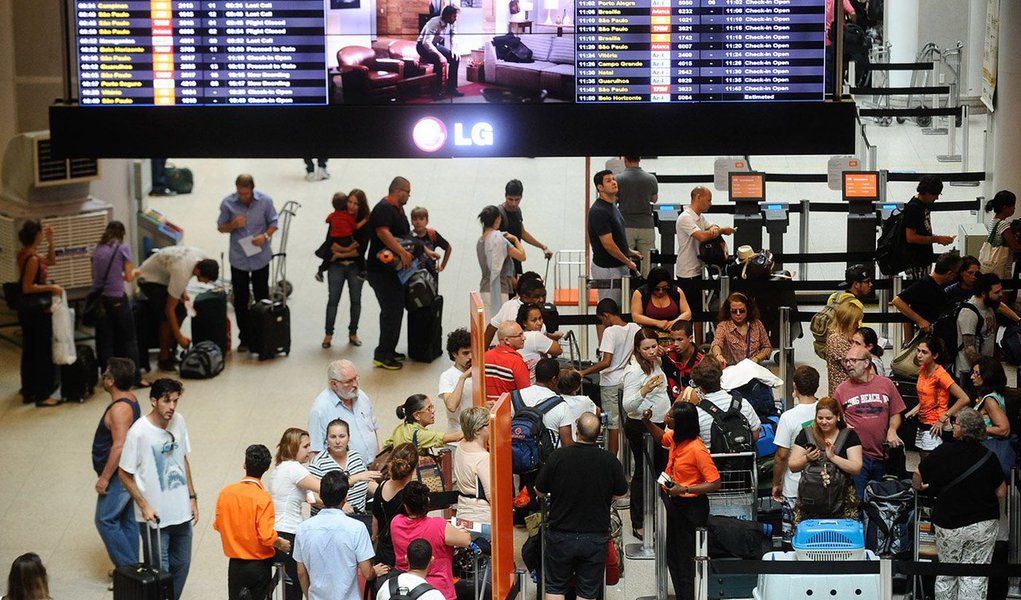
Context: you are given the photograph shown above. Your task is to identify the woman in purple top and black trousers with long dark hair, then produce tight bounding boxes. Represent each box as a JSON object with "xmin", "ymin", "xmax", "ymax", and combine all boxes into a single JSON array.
[{"xmin": 92, "ymin": 220, "xmax": 141, "ymax": 381}]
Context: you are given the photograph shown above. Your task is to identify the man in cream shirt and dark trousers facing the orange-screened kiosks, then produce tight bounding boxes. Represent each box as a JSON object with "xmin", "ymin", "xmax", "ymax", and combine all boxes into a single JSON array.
[{"xmin": 674, "ymin": 186, "xmax": 737, "ymax": 344}]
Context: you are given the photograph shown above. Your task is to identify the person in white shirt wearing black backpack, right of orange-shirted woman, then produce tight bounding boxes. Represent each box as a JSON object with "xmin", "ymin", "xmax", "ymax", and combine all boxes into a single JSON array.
[{"xmin": 691, "ymin": 356, "xmax": 761, "ymax": 454}]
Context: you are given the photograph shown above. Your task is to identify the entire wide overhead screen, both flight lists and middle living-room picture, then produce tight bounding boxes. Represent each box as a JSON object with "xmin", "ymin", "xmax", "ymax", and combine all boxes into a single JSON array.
[{"xmin": 74, "ymin": 0, "xmax": 826, "ymax": 106}]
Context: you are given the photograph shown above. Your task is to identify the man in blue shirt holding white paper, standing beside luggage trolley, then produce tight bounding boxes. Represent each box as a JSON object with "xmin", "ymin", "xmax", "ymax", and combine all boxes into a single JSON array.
[{"xmin": 216, "ymin": 173, "xmax": 277, "ymax": 352}]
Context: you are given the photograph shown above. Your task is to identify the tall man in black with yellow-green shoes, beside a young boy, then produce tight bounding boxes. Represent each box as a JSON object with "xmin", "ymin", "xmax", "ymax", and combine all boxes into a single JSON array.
[{"xmin": 366, "ymin": 177, "xmax": 412, "ymax": 370}]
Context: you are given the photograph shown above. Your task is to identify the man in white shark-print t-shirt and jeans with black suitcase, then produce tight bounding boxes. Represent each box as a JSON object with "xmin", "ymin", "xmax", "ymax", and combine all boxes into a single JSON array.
[{"xmin": 118, "ymin": 379, "xmax": 198, "ymax": 599}]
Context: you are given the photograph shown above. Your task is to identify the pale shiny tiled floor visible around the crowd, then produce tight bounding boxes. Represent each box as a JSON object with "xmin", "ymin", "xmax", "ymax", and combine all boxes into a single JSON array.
[{"xmin": 0, "ymin": 109, "xmax": 985, "ymax": 600}]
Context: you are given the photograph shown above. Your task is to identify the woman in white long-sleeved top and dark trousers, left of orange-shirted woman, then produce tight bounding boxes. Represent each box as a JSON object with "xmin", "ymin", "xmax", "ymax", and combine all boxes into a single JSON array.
[{"xmin": 621, "ymin": 328, "xmax": 670, "ymax": 540}]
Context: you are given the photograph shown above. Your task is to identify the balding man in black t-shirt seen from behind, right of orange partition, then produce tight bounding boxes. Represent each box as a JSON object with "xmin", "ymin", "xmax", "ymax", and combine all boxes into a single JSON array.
[{"xmin": 535, "ymin": 414, "xmax": 628, "ymax": 600}]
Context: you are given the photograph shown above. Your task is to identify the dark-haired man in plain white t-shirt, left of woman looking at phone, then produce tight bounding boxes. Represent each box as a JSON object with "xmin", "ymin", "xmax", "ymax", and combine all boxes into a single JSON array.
[{"xmin": 772, "ymin": 364, "xmax": 819, "ymax": 545}]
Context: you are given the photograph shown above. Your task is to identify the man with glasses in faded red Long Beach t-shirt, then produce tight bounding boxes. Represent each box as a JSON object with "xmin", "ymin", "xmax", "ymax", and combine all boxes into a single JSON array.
[{"xmin": 833, "ymin": 346, "xmax": 905, "ymax": 500}]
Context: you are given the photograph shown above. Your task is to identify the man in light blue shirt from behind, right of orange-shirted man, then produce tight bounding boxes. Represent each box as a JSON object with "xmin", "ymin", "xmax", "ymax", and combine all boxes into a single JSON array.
[{"xmin": 293, "ymin": 470, "xmax": 390, "ymax": 600}]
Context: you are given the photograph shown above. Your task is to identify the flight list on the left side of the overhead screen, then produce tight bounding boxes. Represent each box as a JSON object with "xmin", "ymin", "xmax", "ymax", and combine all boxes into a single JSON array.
[{"xmin": 75, "ymin": 0, "xmax": 327, "ymax": 106}]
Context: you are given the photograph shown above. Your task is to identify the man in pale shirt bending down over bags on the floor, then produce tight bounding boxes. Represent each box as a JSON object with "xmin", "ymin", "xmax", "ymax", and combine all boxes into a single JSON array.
[{"xmin": 136, "ymin": 246, "xmax": 220, "ymax": 370}]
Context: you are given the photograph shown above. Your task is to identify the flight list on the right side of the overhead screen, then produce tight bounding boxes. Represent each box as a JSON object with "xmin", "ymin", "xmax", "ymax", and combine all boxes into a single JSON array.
[{"xmin": 575, "ymin": 0, "xmax": 826, "ymax": 103}]
